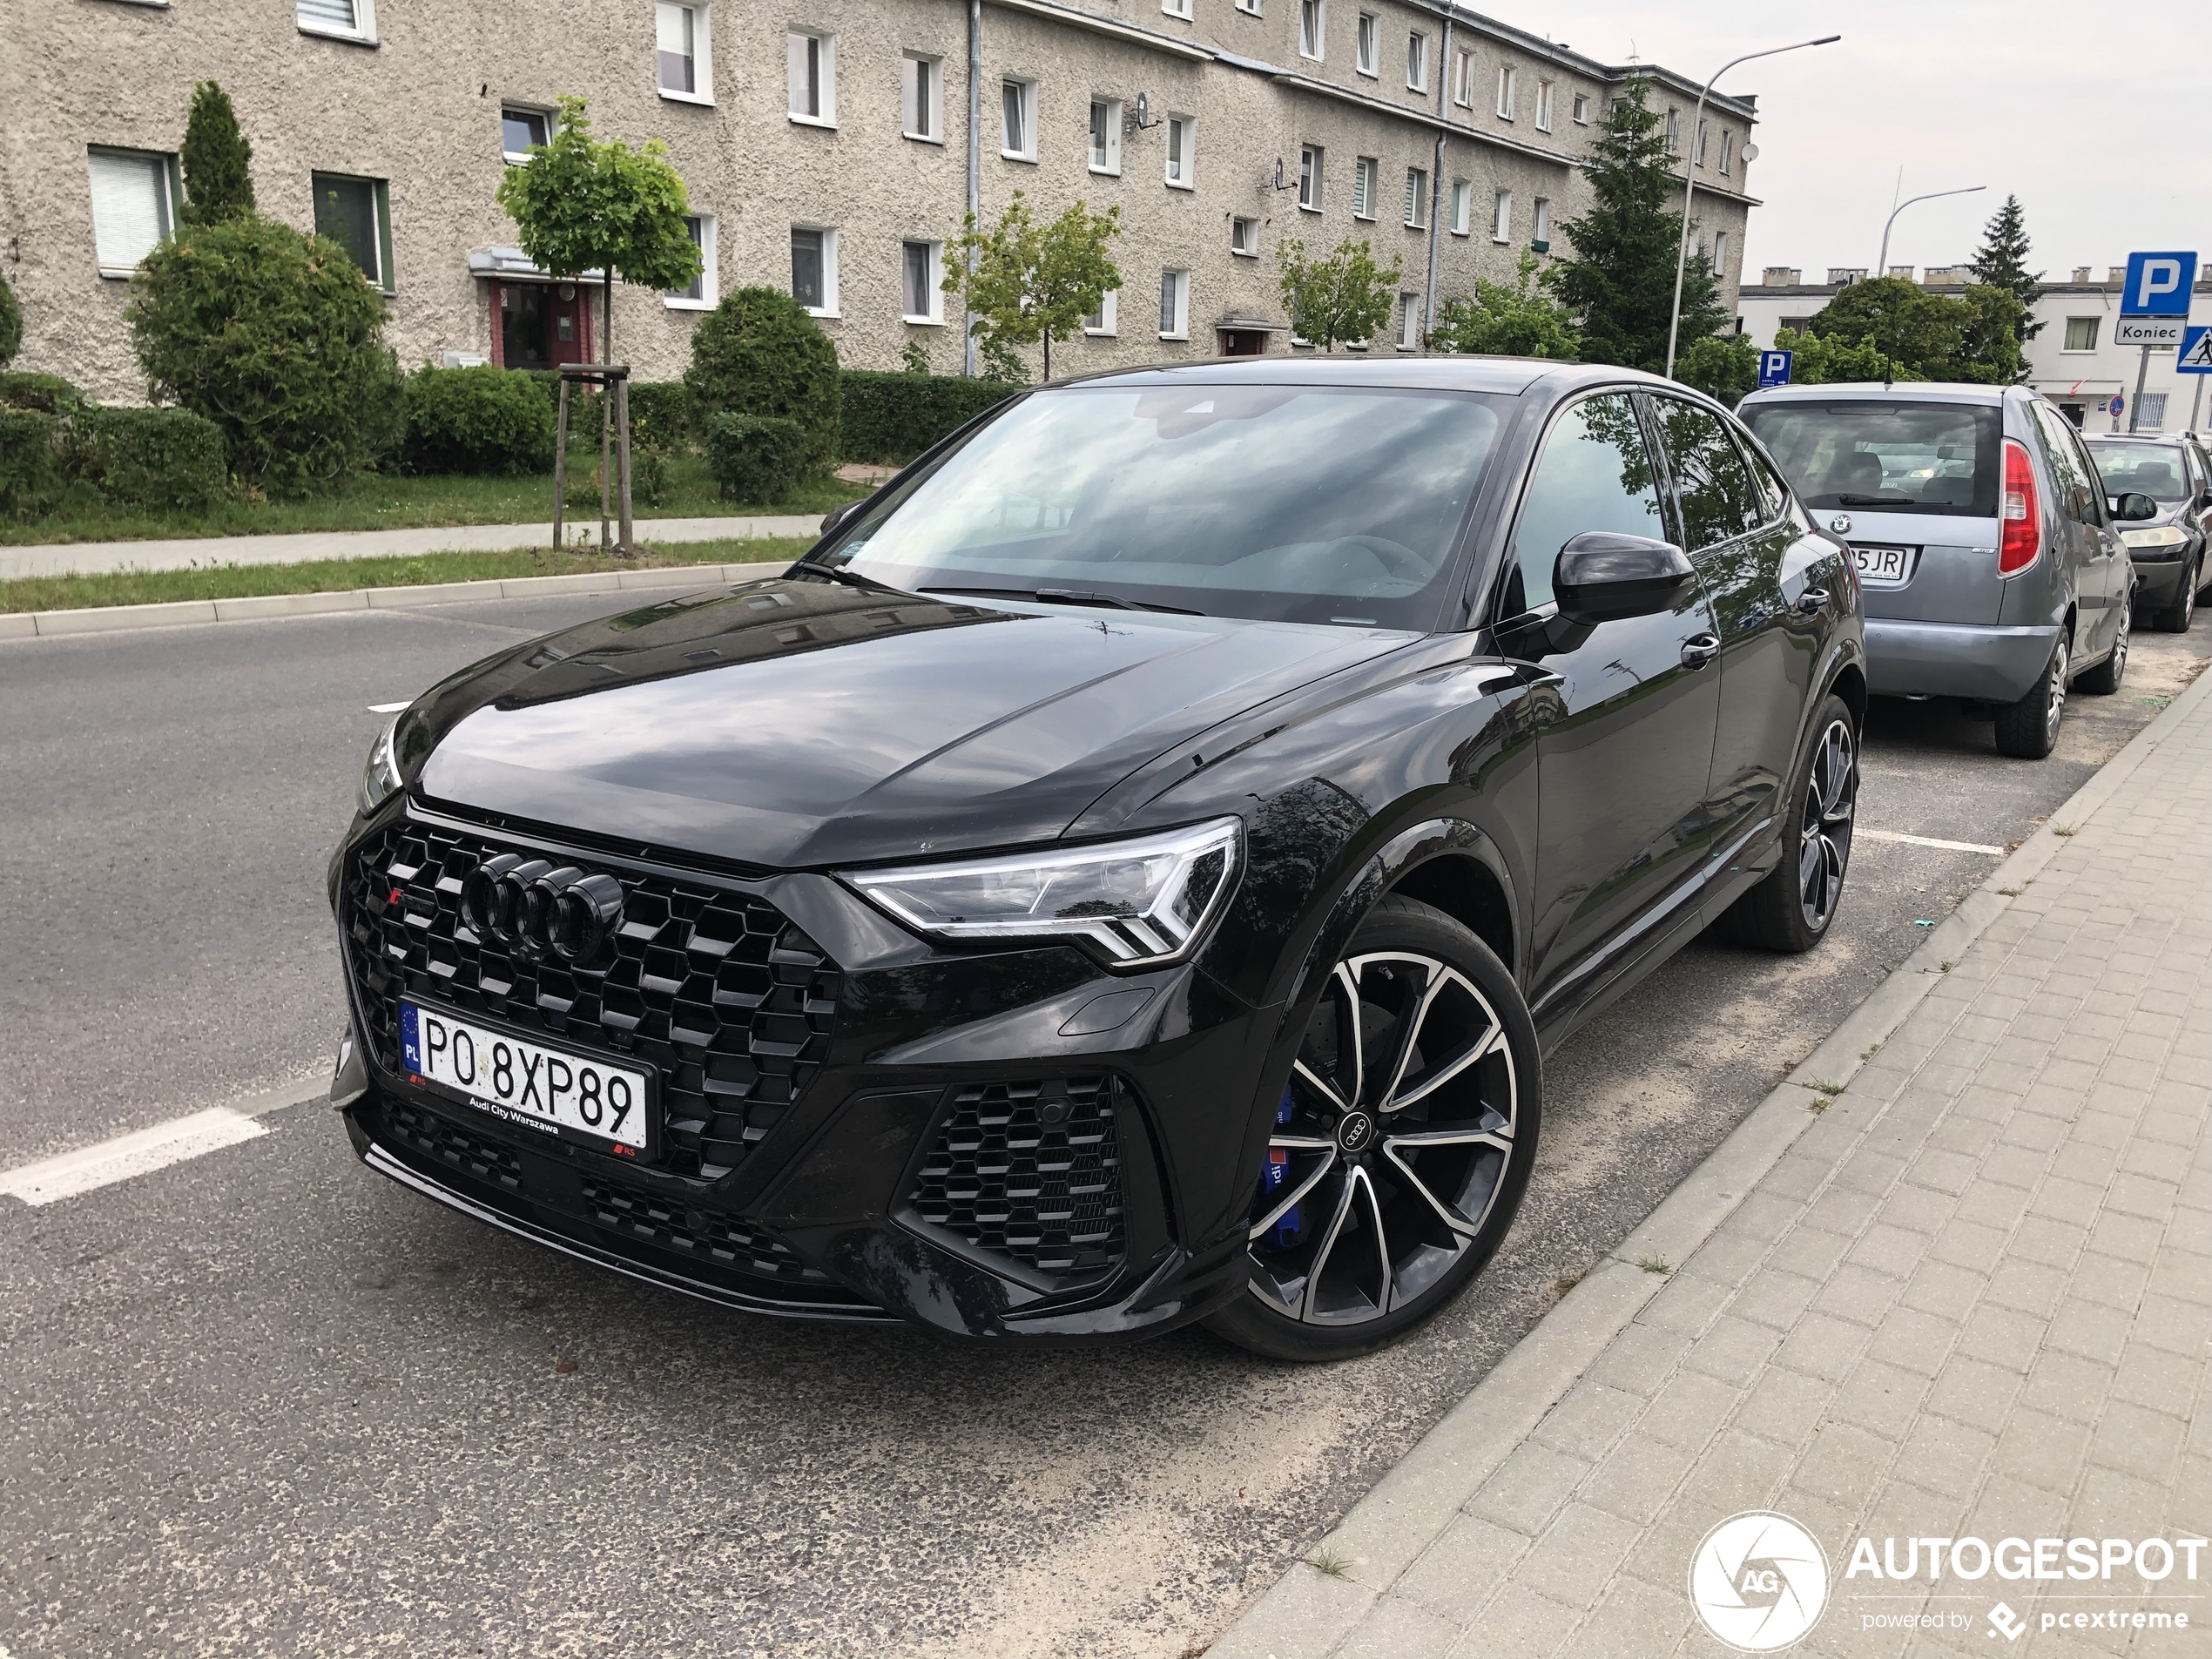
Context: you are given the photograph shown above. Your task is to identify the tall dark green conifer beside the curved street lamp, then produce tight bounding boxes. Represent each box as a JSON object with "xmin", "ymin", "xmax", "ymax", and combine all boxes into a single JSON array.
[{"xmin": 1544, "ymin": 75, "xmax": 1728, "ymax": 374}]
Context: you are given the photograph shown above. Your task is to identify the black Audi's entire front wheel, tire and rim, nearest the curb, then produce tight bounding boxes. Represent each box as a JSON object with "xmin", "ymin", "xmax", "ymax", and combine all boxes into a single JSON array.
[{"xmin": 1208, "ymin": 898, "xmax": 1544, "ymax": 1363}]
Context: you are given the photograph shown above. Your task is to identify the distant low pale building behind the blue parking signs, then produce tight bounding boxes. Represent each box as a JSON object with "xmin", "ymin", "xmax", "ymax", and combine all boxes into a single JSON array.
[{"xmin": 1737, "ymin": 266, "xmax": 2212, "ymax": 431}]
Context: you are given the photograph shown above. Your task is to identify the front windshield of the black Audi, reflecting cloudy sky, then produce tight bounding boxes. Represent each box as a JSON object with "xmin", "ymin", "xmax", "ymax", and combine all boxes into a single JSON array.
[{"xmin": 816, "ymin": 382, "xmax": 1508, "ymax": 631}]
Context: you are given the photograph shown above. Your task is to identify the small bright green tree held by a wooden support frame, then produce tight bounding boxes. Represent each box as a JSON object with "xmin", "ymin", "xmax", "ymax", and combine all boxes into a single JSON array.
[{"xmin": 496, "ymin": 98, "xmax": 701, "ymax": 363}]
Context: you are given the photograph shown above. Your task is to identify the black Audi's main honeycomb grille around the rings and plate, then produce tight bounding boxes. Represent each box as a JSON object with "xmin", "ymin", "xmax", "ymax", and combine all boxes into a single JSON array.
[{"xmin": 341, "ymin": 823, "xmax": 840, "ymax": 1177}]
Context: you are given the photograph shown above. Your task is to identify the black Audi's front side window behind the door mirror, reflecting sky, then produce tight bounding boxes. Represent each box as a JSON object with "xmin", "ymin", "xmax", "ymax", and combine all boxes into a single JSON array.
[{"xmin": 1502, "ymin": 392, "xmax": 1666, "ymax": 617}]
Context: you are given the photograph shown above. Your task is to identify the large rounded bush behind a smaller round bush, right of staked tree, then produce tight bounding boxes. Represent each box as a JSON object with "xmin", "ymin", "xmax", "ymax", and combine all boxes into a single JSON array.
[{"xmin": 684, "ymin": 287, "xmax": 839, "ymax": 471}]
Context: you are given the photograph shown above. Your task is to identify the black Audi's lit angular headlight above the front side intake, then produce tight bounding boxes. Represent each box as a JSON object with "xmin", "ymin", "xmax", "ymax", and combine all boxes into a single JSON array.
[{"xmin": 845, "ymin": 819, "xmax": 1243, "ymax": 967}]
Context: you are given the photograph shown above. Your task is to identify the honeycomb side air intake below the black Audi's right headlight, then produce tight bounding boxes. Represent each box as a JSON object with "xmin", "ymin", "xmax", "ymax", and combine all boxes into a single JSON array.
[{"xmin": 909, "ymin": 1077, "xmax": 1126, "ymax": 1277}]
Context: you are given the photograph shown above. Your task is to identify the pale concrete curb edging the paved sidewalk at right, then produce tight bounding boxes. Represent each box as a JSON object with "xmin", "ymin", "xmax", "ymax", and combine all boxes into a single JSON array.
[{"xmin": 1205, "ymin": 672, "xmax": 2212, "ymax": 1659}]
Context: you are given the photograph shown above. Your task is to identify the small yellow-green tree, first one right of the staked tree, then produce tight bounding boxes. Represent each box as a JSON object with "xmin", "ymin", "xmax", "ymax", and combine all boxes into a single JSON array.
[{"xmin": 945, "ymin": 190, "xmax": 1122, "ymax": 381}]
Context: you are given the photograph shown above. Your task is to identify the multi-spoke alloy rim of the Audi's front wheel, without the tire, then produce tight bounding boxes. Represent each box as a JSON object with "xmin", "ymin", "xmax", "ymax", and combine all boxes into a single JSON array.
[{"xmin": 1250, "ymin": 951, "xmax": 1520, "ymax": 1325}]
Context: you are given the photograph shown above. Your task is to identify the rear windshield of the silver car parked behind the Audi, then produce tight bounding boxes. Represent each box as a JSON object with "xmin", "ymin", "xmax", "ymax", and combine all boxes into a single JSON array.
[{"xmin": 1743, "ymin": 398, "xmax": 2004, "ymax": 517}]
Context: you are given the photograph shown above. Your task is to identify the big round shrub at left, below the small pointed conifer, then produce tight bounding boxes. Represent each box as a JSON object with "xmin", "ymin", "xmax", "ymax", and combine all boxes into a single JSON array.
[{"xmin": 128, "ymin": 217, "xmax": 405, "ymax": 496}]
